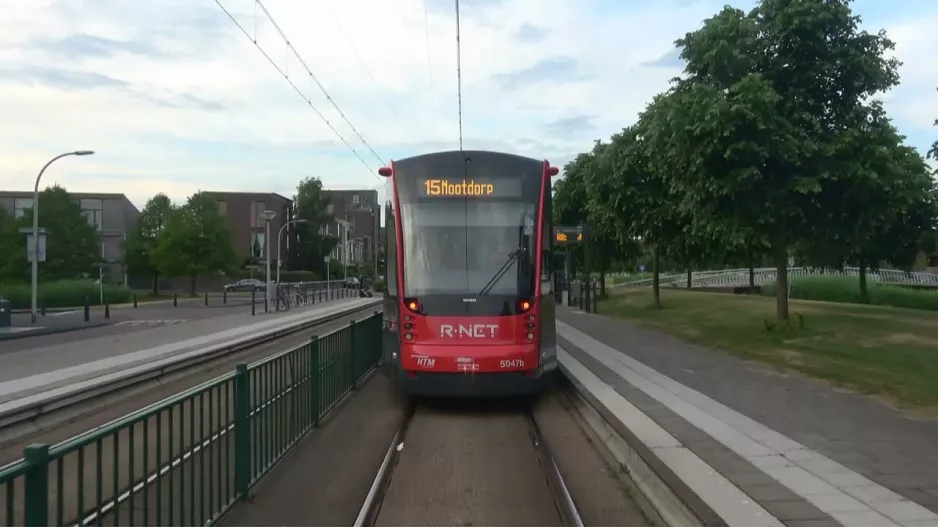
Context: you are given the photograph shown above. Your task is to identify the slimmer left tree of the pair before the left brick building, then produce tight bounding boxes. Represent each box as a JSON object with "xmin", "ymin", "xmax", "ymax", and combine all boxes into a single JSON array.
[{"xmin": 124, "ymin": 192, "xmax": 174, "ymax": 295}]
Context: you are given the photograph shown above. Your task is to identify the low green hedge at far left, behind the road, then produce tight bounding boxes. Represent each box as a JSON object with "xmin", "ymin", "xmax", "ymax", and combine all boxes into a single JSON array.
[{"xmin": 0, "ymin": 280, "xmax": 133, "ymax": 309}]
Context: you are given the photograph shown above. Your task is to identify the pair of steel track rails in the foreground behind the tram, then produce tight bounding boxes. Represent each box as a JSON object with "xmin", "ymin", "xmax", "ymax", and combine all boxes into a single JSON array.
[{"xmin": 353, "ymin": 401, "xmax": 584, "ymax": 527}]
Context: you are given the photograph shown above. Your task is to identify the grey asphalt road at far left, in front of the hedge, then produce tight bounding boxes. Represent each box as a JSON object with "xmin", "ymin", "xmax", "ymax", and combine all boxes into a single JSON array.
[{"xmin": 0, "ymin": 290, "xmax": 362, "ymax": 353}]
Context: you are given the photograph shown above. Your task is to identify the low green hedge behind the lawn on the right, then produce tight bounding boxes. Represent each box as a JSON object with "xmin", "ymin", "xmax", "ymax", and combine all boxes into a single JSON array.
[{"xmin": 762, "ymin": 276, "xmax": 938, "ymax": 311}]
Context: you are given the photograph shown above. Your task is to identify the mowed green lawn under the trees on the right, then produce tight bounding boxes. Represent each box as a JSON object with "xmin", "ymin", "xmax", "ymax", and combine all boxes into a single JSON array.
[{"xmin": 598, "ymin": 288, "xmax": 938, "ymax": 415}]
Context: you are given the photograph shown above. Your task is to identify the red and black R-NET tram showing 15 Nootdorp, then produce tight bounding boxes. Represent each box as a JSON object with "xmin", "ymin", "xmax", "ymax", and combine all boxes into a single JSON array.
[{"xmin": 379, "ymin": 151, "xmax": 558, "ymax": 397}]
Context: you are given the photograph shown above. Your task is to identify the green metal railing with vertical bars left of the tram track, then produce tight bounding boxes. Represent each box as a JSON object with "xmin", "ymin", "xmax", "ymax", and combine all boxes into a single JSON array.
[{"xmin": 0, "ymin": 313, "xmax": 381, "ymax": 526}]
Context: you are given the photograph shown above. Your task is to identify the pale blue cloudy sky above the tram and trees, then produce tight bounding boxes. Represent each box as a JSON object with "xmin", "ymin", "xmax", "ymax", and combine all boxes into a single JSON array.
[{"xmin": 0, "ymin": 0, "xmax": 938, "ymax": 211}]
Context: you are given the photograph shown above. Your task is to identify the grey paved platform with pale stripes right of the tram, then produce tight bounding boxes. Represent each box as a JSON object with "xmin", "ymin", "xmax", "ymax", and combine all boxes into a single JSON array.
[{"xmin": 557, "ymin": 308, "xmax": 938, "ymax": 527}]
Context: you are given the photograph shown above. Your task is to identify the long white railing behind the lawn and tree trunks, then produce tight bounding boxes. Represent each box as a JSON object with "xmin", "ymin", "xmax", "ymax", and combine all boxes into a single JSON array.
[{"xmin": 606, "ymin": 267, "xmax": 938, "ymax": 288}]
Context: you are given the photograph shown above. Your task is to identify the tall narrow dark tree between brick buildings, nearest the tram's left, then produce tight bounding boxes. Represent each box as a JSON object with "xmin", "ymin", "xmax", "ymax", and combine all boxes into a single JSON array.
[{"xmin": 291, "ymin": 177, "xmax": 338, "ymax": 276}]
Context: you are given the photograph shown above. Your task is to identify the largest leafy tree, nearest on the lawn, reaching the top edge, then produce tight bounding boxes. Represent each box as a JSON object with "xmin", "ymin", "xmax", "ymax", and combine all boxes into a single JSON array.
[{"xmin": 659, "ymin": 0, "xmax": 899, "ymax": 322}]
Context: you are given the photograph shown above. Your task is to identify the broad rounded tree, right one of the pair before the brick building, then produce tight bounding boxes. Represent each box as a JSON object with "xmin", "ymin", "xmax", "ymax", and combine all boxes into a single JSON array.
[{"xmin": 151, "ymin": 192, "xmax": 238, "ymax": 295}]
